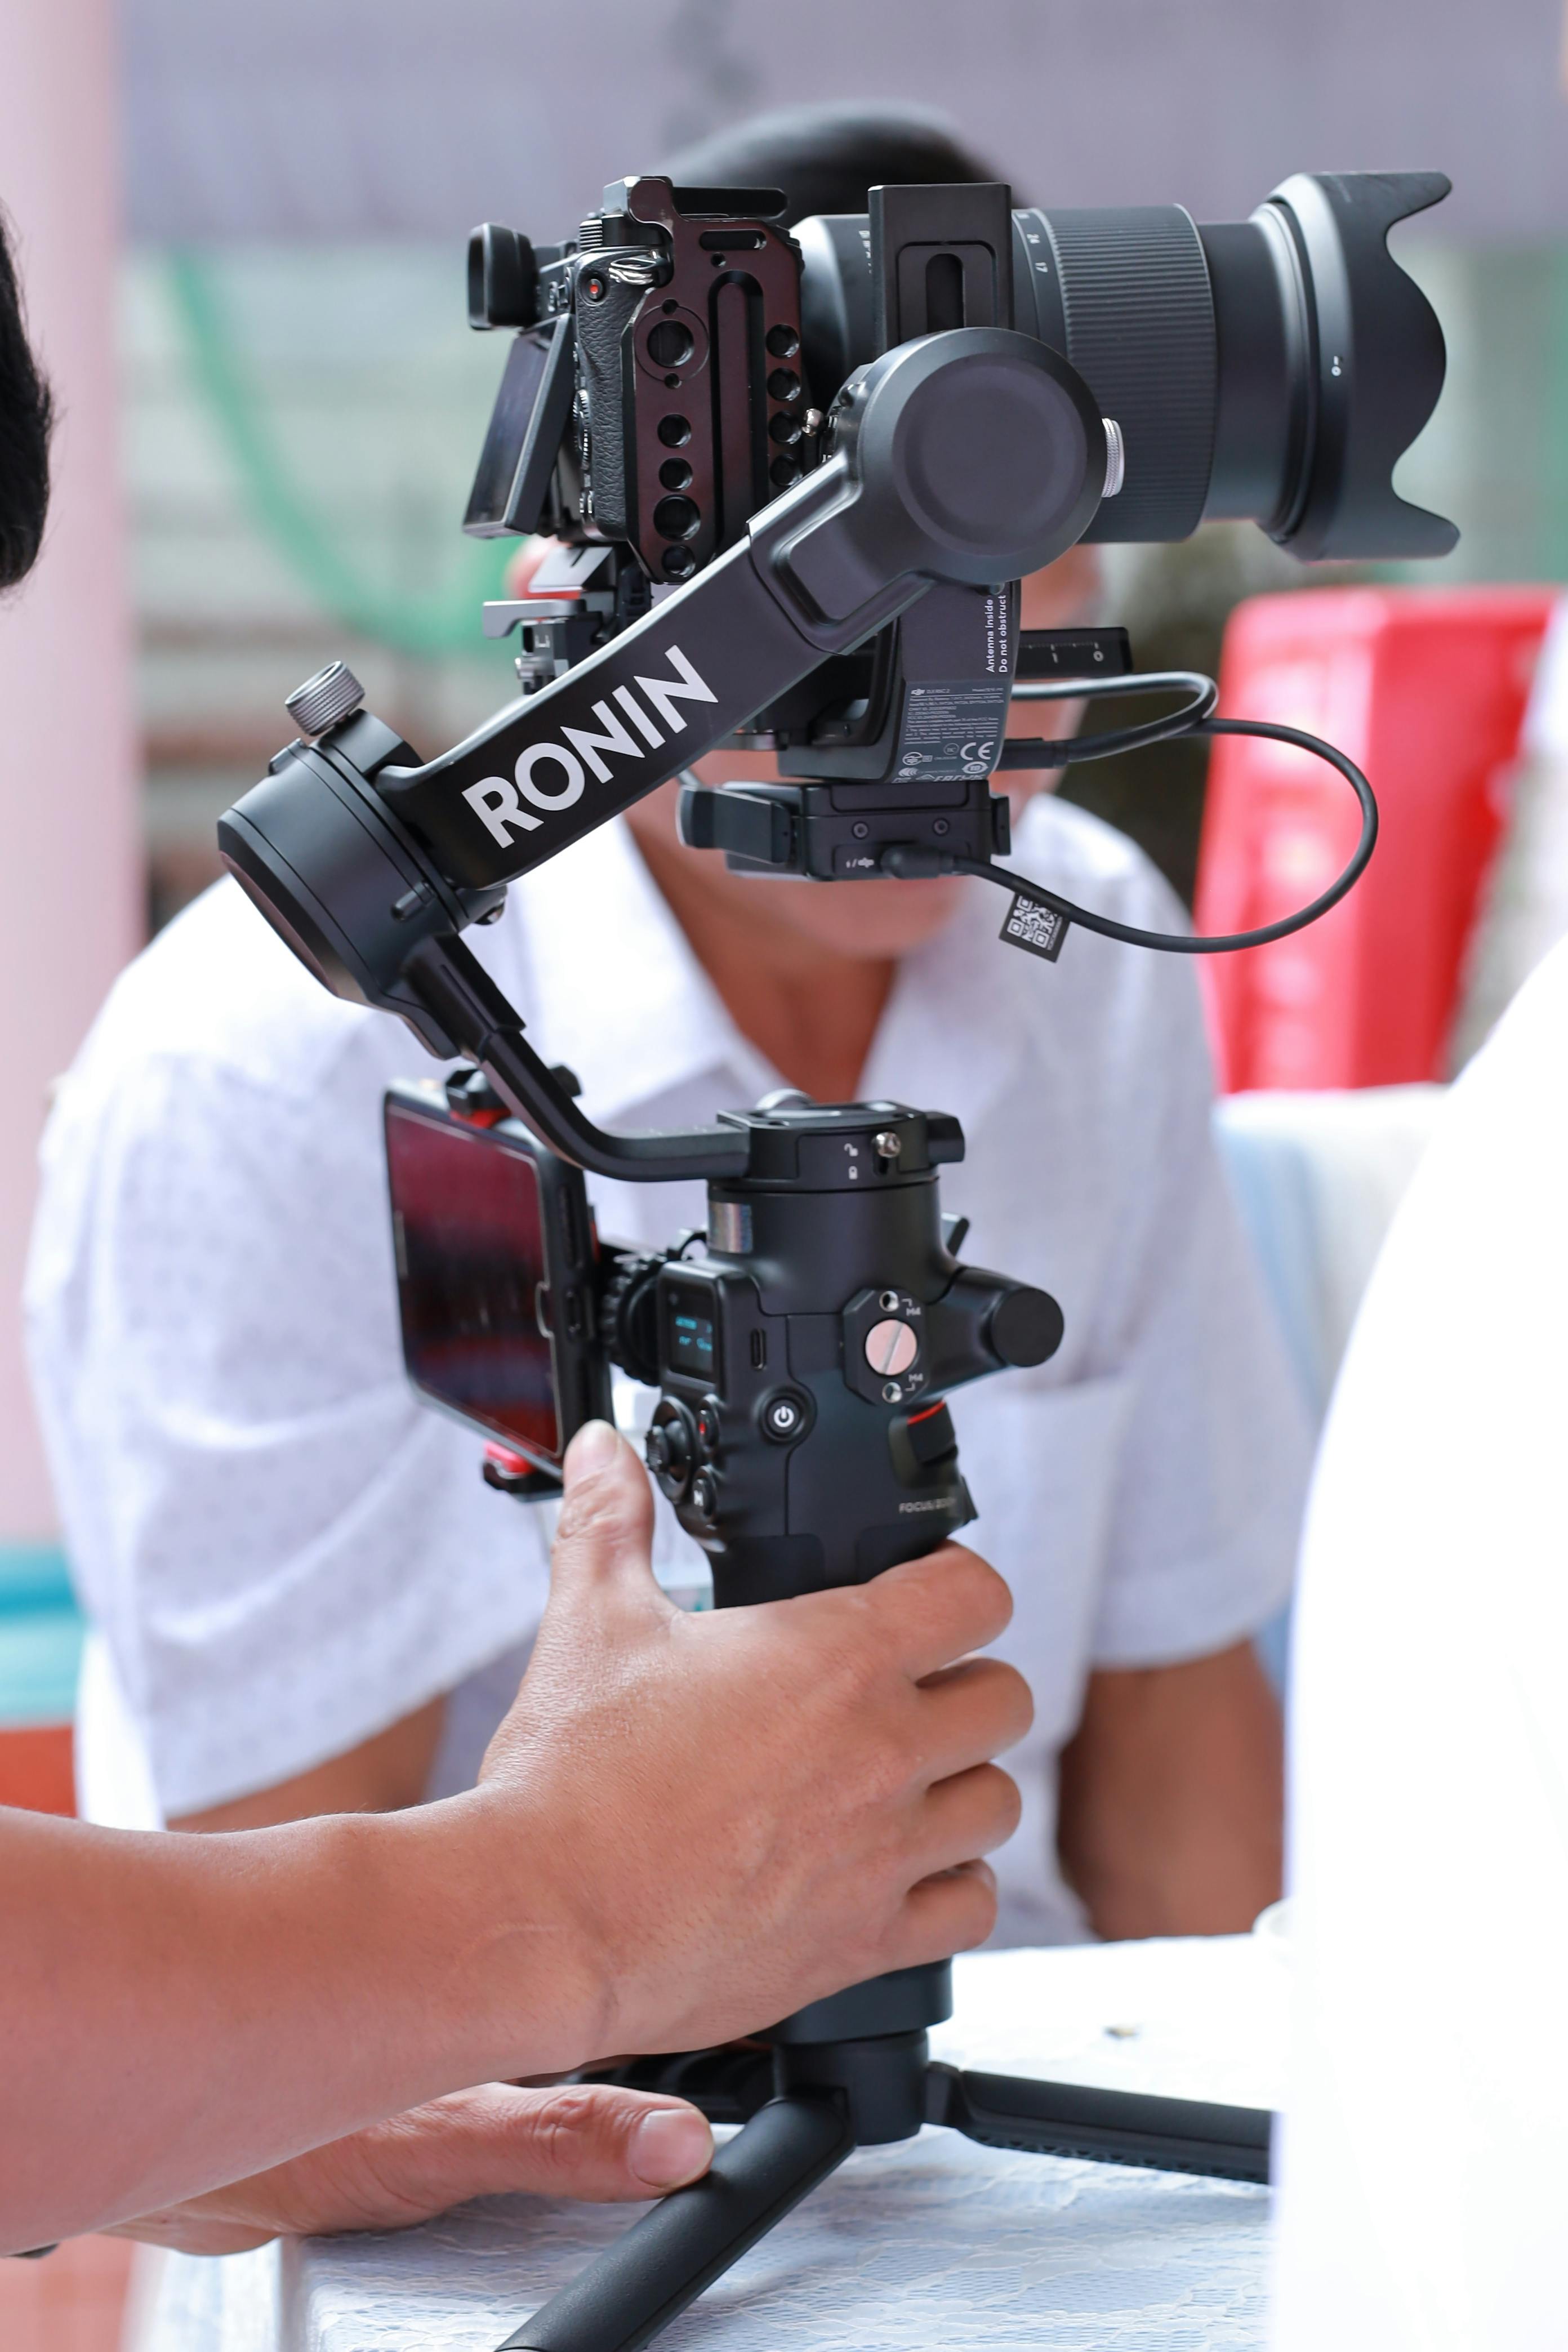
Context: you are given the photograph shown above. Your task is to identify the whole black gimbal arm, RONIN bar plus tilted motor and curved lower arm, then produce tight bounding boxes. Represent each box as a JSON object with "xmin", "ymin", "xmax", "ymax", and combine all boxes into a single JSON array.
[{"xmin": 219, "ymin": 327, "xmax": 1105, "ymax": 1181}]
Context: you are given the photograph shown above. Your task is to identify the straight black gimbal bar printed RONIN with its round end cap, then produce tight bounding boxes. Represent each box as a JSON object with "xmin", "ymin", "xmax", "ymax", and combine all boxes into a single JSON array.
[{"xmin": 376, "ymin": 329, "xmax": 1105, "ymax": 889}]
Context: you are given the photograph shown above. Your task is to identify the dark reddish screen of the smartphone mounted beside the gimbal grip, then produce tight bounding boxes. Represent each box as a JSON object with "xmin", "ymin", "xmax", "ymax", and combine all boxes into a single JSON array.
[{"xmin": 386, "ymin": 1103, "xmax": 559, "ymax": 1460}]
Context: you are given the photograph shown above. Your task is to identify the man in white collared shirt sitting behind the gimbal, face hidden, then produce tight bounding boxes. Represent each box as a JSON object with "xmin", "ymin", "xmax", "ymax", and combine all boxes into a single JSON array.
[{"xmin": 28, "ymin": 115, "xmax": 1307, "ymax": 1943}]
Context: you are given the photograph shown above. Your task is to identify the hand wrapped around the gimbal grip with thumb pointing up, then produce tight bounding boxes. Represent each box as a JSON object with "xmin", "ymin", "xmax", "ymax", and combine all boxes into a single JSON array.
[{"xmin": 479, "ymin": 1423, "xmax": 1032, "ymax": 2065}]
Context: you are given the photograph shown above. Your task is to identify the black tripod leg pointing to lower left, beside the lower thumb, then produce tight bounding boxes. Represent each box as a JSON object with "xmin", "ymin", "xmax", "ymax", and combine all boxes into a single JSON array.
[{"xmin": 501, "ymin": 2098, "xmax": 856, "ymax": 2352}]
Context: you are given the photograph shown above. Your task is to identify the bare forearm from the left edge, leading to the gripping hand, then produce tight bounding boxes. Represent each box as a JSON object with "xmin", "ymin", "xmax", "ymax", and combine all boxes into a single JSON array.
[{"xmin": 0, "ymin": 1794, "xmax": 590, "ymax": 2248}]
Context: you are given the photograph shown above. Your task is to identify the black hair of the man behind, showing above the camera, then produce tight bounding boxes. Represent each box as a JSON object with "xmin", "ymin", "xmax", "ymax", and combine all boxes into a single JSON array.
[{"xmin": 663, "ymin": 101, "xmax": 1001, "ymax": 224}]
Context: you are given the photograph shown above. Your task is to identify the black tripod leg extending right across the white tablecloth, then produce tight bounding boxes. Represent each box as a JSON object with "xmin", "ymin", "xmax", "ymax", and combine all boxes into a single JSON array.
[{"xmin": 926, "ymin": 2065, "xmax": 1274, "ymax": 2180}]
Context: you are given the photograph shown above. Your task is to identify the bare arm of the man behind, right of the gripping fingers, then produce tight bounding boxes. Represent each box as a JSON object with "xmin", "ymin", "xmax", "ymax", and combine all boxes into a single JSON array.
[{"xmin": 1058, "ymin": 1642, "xmax": 1284, "ymax": 1938}]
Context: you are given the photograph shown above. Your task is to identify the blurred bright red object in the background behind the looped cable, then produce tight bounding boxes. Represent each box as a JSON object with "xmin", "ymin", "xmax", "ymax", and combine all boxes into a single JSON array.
[{"xmin": 1194, "ymin": 588, "xmax": 1558, "ymax": 1094}]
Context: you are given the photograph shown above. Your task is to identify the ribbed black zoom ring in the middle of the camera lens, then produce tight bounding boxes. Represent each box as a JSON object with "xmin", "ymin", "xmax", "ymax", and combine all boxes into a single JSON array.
[{"xmin": 1046, "ymin": 204, "xmax": 1218, "ymax": 541}]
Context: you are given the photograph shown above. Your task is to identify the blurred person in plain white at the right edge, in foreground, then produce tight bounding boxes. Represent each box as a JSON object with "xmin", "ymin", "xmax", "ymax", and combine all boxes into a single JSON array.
[{"xmin": 1274, "ymin": 926, "xmax": 1568, "ymax": 2352}]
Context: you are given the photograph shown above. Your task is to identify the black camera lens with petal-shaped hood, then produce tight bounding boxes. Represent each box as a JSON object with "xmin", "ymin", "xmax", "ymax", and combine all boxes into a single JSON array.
[{"xmin": 804, "ymin": 172, "xmax": 1458, "ymax": 560}]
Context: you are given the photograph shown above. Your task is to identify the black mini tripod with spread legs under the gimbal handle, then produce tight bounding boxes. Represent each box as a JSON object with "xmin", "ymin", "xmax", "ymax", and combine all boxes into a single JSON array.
[{"xmin": 501, "ymin": 1962, "xmax": 1272, "ymax": 2352}]
